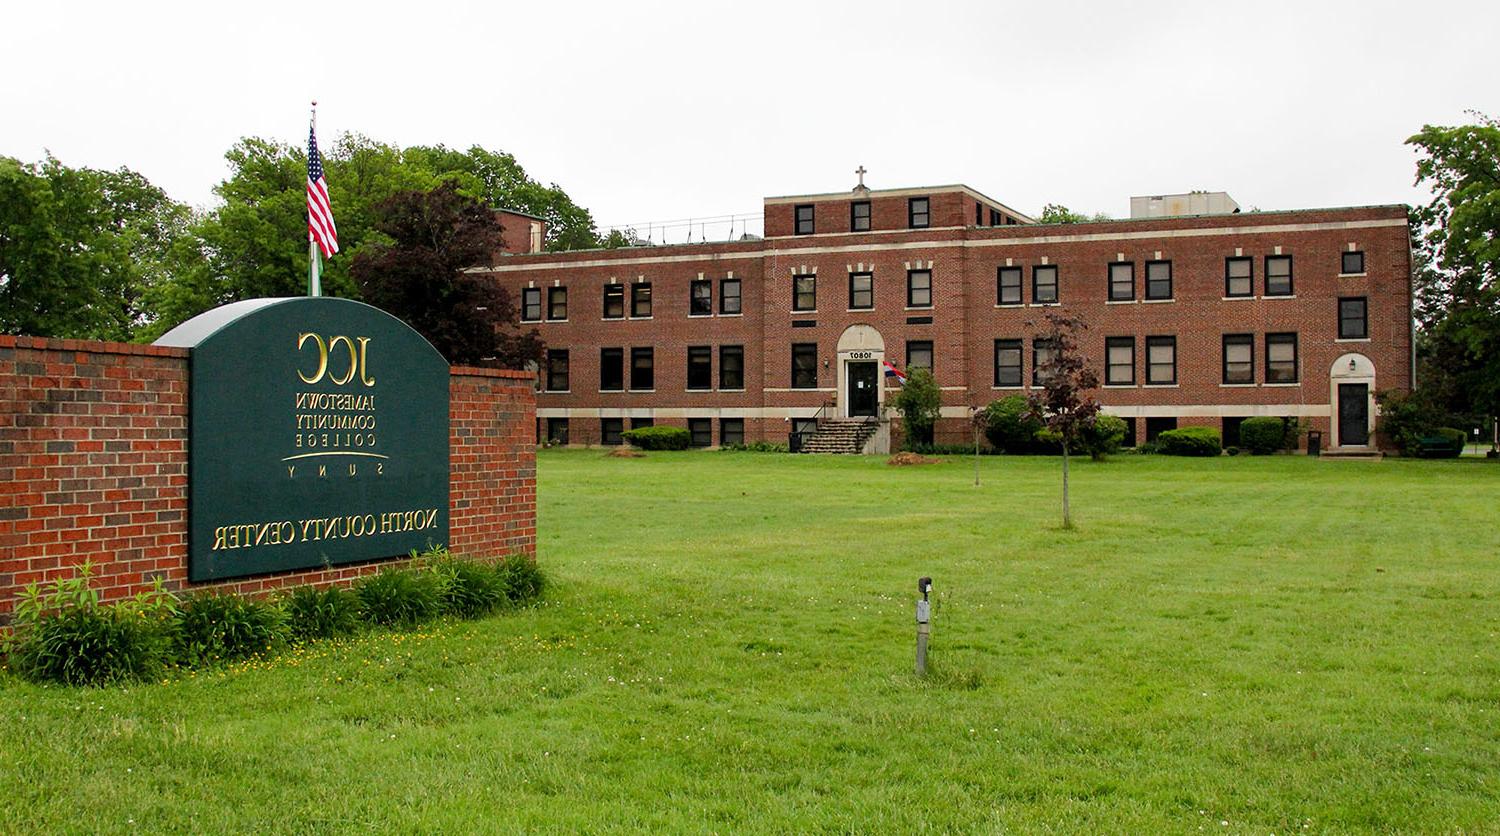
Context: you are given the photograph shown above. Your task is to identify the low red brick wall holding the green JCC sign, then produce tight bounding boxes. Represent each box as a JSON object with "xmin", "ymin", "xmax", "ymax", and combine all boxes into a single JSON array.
[{"xmin": 0, "ymin": 336, "xmax": 536, "ymax": 623}]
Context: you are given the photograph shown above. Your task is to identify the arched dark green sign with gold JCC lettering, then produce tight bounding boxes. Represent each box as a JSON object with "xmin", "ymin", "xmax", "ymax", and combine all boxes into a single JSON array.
[{"xmin": 158, "ymin": 297, "xmax": 449, "ymax": 581}]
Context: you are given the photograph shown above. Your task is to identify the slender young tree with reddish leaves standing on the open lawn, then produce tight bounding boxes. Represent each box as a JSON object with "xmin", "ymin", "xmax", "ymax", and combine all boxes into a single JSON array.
[{"xmin": 1028, "ymin": 314, "xmax": 1100, "ymax": 528}]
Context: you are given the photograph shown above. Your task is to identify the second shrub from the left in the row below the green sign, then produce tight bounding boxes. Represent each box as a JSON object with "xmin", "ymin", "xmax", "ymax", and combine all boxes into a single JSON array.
[{"xmin": 173, "ymin": 593, "xmax": 287, "ymax": 666}]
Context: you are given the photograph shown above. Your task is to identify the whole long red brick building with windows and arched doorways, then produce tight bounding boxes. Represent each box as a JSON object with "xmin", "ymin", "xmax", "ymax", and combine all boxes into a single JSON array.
[{"xmin": 485, "ymin": 180, "xmax": 1413, "ymax": 452}]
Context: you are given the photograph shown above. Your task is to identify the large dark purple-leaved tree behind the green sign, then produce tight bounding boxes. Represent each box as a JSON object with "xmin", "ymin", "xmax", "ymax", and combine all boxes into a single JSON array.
[{"xmin": 350, "ymin": 180, "xmax": 542, "ymax": 368}]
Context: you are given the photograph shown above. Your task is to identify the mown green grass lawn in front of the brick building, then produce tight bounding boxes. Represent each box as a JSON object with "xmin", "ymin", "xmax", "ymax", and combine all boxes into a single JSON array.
[{"xmin": 0, "ymin": 450, "xmax": 1500, "ymax": 834}]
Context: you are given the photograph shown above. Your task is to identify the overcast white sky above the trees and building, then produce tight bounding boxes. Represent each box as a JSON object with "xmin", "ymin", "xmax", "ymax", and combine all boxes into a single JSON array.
[{"xmin": 0, "ymin": 0, "xmax": 1500, "ymax": 238}]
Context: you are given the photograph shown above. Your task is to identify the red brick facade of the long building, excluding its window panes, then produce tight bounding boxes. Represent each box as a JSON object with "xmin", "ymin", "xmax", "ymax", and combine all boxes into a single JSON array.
[{"xmin": 489, "ymin": 186, "xmax": 1412, "ymax": 447}]
